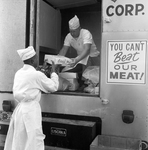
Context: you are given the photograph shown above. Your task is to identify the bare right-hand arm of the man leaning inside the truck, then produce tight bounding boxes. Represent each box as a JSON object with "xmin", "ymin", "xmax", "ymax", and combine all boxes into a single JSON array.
[{"xmin": 69, "ymin": 44, "xmax": 91, "ymax": 67}]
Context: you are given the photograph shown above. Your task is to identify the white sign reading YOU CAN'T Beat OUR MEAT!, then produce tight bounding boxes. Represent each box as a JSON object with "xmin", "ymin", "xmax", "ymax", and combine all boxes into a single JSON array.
[{"xmin": 107, "ymin": 40, "xmax": 147, "ymax": 84}]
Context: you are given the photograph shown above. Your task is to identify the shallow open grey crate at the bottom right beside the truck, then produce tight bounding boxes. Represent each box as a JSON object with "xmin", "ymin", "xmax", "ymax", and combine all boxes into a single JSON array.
[{"xmin": 90, "ymin": 135, "xmax": 140, "ymax": 150}]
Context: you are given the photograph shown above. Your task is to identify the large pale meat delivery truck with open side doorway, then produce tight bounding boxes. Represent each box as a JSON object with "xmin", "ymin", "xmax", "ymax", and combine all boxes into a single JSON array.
[{"xmin": 0, "ymin": 0, "xmax": 148, "ymax": 150}]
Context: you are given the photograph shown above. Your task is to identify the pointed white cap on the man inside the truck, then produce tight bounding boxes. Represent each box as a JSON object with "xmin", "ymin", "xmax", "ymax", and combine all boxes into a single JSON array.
[{"xmin": 69, "ymin": 15, "xmax": 80, "ymax": 30}]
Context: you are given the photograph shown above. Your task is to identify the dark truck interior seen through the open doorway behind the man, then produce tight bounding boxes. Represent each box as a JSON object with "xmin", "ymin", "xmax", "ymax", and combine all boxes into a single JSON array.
[{"xmin": 38, "ymin": 0, "xmax": 102, "ymax": 96}]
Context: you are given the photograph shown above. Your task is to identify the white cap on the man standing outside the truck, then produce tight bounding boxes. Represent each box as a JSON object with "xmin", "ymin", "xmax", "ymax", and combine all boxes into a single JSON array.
[{"xmin": 17, "ymin": 46, "xmax": 36, "ymax": 60}]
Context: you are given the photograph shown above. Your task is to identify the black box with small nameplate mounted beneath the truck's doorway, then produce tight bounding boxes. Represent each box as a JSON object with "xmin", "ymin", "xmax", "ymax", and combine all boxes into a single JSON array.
[{"xmin": 43, "ymin": 117, "xmax": 96, "ymax": 150}]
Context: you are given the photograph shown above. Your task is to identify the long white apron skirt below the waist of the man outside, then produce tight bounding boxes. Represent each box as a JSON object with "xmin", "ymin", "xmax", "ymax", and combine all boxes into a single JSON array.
[{"xmin": 4, "ymin": 101, "xmax": 45, "ymax": 150}]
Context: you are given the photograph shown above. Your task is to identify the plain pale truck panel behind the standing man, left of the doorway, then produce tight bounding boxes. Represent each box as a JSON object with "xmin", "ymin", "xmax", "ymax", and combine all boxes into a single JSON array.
[{"xmin": 0, "ymin": 0, "xmax": 26, "ymax": 92}]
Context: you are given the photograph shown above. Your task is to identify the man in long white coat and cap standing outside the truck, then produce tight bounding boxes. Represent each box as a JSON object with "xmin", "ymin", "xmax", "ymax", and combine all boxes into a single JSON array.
[{"xmin": 4, "ymin": 46, "xmax": 59, "ymax": 150}]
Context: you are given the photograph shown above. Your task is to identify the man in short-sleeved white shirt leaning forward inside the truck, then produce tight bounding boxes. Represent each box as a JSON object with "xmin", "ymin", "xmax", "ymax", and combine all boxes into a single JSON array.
[{"xmin": 59, "ymin": 15, "xmax": 99, "ymax": 86}]
